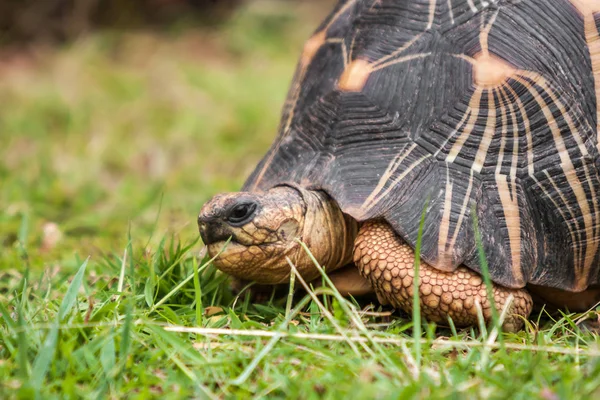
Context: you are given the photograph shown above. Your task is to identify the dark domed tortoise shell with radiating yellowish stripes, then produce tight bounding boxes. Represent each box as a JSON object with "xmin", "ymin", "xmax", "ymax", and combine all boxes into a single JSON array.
[{"xmin": 244, "ymin": 0, "xmax": 600, "ymax": 292}]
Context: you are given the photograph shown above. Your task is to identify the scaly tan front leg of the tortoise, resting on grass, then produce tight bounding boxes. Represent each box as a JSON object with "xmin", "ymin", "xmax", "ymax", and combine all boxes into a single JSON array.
[{"xmin": 354, "ymin": 221, "xmax": 533, "ymax": 331}]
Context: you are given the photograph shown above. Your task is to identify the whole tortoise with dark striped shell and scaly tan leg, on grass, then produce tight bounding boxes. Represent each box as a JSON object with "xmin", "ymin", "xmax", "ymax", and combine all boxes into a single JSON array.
[{"xmin": 198, "ymin": 0, "xmax": 600, "ymax": 331}]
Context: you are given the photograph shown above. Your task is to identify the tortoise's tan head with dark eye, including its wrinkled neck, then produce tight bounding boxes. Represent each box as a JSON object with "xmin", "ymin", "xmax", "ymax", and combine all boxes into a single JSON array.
[{"xmin": 198, "ymin": 186, "xmax": 356, "ymax": 284}]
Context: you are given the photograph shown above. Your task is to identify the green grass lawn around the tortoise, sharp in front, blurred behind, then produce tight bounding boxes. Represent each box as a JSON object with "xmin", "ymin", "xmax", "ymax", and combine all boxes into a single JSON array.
[{"xmin": 0, "ymin": 1, "xmax": 600, "ymax": 399}]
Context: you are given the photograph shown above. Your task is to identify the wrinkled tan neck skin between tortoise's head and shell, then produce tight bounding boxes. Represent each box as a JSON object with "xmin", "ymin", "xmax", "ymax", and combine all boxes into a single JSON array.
[{"xmin": 292, "ymin": 189, "xmax": 358, "ymax": 279}]
